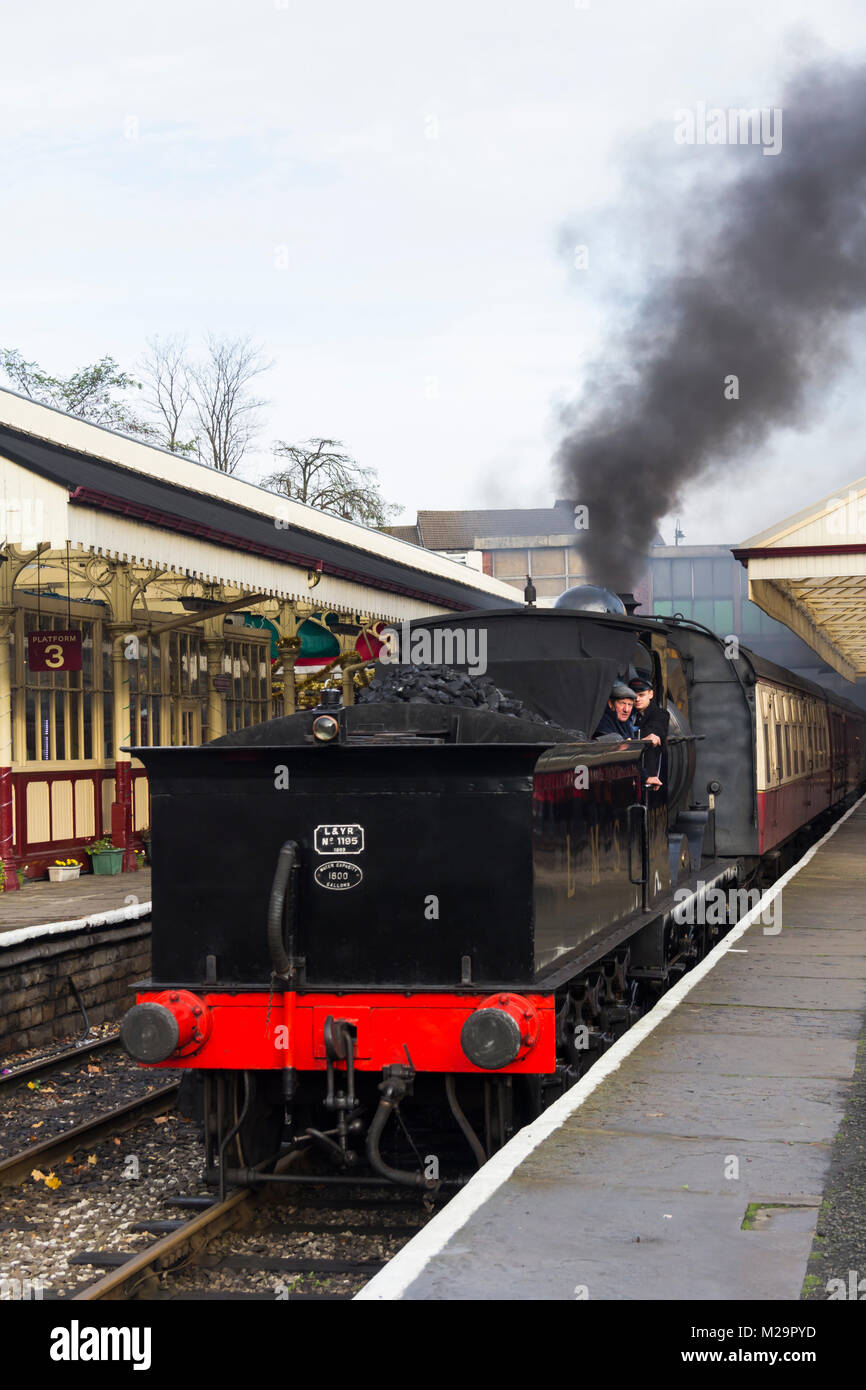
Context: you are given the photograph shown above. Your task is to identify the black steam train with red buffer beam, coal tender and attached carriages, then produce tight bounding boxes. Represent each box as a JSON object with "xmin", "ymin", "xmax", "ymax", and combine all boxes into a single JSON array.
[{"xmin": 122, "ymin": 587, "xmax": 866, "ymax": 1190}]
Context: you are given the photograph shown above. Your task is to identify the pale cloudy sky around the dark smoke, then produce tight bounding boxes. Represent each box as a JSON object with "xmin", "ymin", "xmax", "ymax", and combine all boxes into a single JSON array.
[{"xmin": 0, "ymin": 0, "xmax": 866, "ymax": 543}]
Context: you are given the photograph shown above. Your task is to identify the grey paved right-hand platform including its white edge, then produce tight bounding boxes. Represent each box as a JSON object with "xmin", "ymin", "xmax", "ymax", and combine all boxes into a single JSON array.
[{"xmin": 357, "ymin": 798, "xmax": 866, "ymax": 1301}]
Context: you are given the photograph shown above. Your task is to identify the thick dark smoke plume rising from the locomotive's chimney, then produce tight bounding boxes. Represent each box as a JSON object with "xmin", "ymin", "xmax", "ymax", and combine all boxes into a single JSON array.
[{"xmin": 555, "ymin": 64, "xmax": 866, "ymax": 589}]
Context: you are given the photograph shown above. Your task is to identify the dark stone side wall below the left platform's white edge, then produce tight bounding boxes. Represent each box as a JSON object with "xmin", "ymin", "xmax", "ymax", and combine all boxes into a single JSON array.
[{"xmin": 0, "ymin": 917, "xmax": 150, "ymax": 1056}]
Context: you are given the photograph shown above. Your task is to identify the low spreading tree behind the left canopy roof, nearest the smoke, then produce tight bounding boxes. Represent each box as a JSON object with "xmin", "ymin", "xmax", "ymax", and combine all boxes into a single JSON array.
[{"xmin": 264, "ymin": 439, "xmax": 400, "ymax": 527}]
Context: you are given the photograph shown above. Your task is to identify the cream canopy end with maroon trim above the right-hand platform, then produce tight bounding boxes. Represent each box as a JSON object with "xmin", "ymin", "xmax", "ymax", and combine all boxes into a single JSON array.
[{"xmin": 734, "ymin": 478, "xmax": 866, "ymax": 681}]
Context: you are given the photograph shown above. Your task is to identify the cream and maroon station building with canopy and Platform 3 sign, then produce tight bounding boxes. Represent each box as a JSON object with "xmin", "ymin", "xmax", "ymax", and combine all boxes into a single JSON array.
[{"xmin": 0, "ymin": 391, "xmax": 518, "ymax": 891}]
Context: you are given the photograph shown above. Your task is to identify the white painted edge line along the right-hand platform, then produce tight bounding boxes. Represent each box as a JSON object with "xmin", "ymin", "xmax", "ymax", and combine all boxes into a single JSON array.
[{"xmin": 353, "ymin": 795, "xmax": 866, "ymax": 1302}]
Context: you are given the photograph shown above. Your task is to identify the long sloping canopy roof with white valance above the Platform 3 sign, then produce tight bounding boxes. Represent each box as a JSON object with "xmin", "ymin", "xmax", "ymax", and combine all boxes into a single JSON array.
[{"xmin": 0, "ymin": 380, "xmax": 520, "ymax": 621}]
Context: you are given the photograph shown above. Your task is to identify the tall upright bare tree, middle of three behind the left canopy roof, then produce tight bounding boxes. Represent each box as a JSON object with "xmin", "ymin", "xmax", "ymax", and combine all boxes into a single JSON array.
[{"xmin": 189, "ymin": 335, "xmax": 272, "ymax": 473}]
